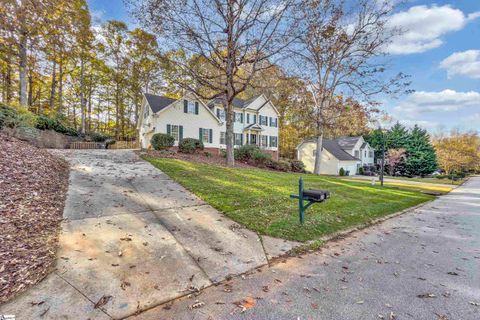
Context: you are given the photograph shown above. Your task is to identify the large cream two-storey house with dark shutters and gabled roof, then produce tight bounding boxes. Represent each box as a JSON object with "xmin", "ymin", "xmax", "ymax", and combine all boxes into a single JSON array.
[{"xmin": 137, "ymin": 93, "xmax": 279, "ymax": 159}]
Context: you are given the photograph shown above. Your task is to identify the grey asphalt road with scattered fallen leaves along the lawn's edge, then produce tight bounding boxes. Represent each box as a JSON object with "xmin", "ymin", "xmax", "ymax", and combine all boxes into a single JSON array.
[{"xmin": 134, "ymin": 177, "xmax": 480, "ymax": 320}]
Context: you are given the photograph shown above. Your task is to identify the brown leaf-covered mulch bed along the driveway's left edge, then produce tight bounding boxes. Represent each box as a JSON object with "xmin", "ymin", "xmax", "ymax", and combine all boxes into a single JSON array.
[{"xmin": 0, "ymin": 133, "xmax": 69, "ymax": 302}]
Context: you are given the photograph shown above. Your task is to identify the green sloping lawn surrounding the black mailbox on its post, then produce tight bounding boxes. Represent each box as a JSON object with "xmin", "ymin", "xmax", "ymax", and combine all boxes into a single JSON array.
[{"xmin": 145, "ymin": 158, "xmax": 433, "ymax": 241}]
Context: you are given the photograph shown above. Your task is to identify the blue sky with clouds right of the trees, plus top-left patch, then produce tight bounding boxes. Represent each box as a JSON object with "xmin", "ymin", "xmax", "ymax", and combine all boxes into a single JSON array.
[{"xmin": 88, "ymin": 0, "xmax": 480, "ymax": 132}]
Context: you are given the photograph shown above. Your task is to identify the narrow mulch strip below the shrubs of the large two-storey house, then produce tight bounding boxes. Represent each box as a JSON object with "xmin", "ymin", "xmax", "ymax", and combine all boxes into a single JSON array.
[{"xmin": 137, "ymin": 150, "xmax": 255, "ymax": 168}]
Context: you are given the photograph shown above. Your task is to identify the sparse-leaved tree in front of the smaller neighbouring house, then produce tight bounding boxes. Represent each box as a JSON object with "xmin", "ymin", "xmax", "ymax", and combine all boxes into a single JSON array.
[{"xmin": 292, "ymin": 0, "xmax": 409, "ymax": 174}]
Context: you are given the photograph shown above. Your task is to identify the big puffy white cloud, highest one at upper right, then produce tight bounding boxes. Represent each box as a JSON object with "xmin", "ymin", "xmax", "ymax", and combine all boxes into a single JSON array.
[{"xmin": 386, "ymin": 5, "xmax": 480, "ymax": 54}]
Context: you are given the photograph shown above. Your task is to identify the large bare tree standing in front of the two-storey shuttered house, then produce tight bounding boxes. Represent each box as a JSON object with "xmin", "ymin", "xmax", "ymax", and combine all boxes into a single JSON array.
[{"xmin": 125, "ymin": 0, "xmax": 295, "ymax": 166}]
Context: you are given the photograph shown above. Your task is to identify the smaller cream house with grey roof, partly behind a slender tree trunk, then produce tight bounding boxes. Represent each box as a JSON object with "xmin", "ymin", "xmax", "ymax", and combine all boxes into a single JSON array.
[{"xmin": 297, "ymin": 137, "xmax": 374, "ymax": 175}]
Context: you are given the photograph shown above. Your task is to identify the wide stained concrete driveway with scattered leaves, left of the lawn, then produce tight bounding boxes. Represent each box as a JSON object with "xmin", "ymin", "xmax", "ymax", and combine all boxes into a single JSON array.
[{"xmin": 0, "ymin": 150, "xmax": 296, "ymax": 319}]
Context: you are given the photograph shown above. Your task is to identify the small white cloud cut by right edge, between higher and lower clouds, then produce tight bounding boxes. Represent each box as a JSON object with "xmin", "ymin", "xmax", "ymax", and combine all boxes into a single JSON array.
[{"xmin": 440, "ymin": 50, "xmax": 480, "ymax": 79}]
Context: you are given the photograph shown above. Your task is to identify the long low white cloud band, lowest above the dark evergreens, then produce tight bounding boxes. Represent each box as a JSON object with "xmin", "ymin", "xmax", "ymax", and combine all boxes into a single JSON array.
[{"xmin": 393, "ymin": 89, "xmax": 480, "ymax": 120}]
